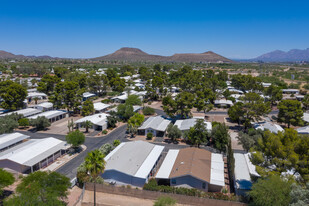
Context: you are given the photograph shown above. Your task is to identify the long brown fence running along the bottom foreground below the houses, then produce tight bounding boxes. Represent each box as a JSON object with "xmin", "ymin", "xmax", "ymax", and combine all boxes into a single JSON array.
[{"xmin": 82, "ymin": 183, "xmax": 246, "ymax": 206}]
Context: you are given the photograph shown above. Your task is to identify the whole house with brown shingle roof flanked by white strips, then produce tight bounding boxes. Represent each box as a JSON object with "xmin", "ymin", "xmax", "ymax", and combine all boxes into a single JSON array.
[{"xmin": 156, "ymin": 147, "xmax": 225, "ymax": 192}]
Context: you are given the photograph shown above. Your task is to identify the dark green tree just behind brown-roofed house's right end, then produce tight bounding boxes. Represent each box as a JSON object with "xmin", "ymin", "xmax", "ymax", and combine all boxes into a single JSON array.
[{"xmin": 211, "ymin": 123, "xmax": 230, "ymax": 152}]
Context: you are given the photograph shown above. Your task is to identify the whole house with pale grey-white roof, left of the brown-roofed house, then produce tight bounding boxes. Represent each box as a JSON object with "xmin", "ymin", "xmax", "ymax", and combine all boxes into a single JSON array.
[{"xmin": 102, "ymin": 141, "xmax": 164, "ymax": 187}]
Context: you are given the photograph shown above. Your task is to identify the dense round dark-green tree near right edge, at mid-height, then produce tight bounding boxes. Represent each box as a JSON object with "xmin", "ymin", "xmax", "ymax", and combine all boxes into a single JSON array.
[{"xmin": 278, "ymin": 100, "xmax": 303, "ymax": 128}]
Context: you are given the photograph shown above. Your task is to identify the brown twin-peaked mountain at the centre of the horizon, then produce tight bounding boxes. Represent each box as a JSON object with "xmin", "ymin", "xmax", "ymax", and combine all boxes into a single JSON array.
[{"xmin": 94, "ymin": 47, "xmax": 232, "ymax": 62}]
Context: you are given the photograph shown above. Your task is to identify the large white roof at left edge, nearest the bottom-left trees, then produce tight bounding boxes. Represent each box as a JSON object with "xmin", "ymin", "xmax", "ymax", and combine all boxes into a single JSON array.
[{"xmin": 0, "ymin": 137, "xmax": 66, "ymax": 166}]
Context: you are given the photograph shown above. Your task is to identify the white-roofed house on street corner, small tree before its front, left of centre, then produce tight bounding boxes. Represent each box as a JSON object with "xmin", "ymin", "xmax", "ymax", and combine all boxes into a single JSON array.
[{"xmin": 75, "ymin": 113, "xmax": 109, "ymax": 131}]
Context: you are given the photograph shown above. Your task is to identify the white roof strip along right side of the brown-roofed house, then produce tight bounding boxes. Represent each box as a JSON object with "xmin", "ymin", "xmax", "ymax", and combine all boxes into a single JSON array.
[{"xmin": 210, "ymin": 153, "xmax": 225, "ymax": 186}]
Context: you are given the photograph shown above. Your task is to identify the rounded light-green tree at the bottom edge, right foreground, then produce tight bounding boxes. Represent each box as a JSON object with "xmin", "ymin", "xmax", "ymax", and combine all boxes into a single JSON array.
[{"xmin": 249, "ymin": 176, "xmax": 291, "ymax": 206}]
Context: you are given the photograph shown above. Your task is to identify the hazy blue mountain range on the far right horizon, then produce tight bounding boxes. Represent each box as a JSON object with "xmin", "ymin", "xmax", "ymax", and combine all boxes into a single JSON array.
[{"xmin": 253, "ymin": 48, "xmax": 309, "ymax": 62}]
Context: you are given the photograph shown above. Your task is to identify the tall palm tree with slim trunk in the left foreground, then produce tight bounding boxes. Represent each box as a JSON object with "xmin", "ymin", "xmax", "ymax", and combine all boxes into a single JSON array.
[{"xmin": 85, "ymin": 150, "xmax": 106, "ymax": 206}]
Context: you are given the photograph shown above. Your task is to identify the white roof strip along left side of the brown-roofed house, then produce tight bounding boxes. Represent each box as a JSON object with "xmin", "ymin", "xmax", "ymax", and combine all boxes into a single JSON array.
[{"xmin": 156, "ymin": 149, "xmax": 179, "ymax": 179}]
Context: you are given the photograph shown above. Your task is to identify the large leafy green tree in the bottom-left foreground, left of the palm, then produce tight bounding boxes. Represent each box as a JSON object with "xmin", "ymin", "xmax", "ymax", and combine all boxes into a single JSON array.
[{"xmin": 4, "ymin": 171, "xmax": 71, "ymax": 206}]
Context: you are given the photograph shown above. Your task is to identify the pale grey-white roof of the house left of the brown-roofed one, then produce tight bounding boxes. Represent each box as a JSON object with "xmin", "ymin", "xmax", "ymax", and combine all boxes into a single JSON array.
[{"xmin": 104, "ymin": 141, "xmax": 164, "ymax": 178}]
